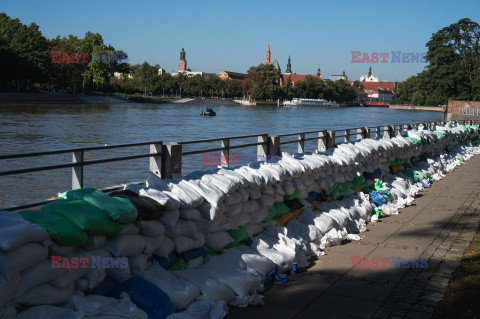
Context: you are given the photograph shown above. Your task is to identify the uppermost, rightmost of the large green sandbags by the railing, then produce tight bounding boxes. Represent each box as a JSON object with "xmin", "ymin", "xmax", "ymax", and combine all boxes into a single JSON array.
[{"xmin": 58, "ymin": 188, "xmax": 138, "ymax": 224}]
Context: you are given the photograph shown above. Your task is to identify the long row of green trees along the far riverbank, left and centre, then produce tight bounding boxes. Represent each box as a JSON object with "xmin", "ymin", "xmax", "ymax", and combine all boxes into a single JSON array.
[{"xmin": 0, "ymin": 13, "xmax": 356, "ymax": 102}]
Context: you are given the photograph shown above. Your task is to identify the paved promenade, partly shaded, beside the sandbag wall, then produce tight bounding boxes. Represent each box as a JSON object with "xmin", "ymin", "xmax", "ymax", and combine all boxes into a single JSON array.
[{"xmin": 229, "ymin": 155, "xmax": 480, "ymax": 319}]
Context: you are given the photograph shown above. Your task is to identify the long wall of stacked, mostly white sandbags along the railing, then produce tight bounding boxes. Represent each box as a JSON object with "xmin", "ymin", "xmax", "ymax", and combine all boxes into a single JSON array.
[{"xmin": 0, "ymin": 125, "xmax": 479, "ymax": 319}]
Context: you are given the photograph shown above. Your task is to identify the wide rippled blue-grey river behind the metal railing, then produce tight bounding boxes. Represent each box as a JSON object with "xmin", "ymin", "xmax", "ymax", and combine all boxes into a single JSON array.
[{"xmin": 0, "ymin": 100, "xmax": 441, "ymax": 207}]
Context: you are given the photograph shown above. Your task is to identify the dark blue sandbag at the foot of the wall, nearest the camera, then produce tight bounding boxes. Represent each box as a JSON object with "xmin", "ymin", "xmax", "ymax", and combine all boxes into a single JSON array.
[{"xmin": 113, "ymin": 277, "xmax": 175, "ymax": 319}]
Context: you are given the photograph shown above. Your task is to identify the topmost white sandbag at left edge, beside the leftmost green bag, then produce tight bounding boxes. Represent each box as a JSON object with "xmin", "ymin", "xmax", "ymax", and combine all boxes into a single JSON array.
[{"xmin": 0, "ymin": 211, "xmax": 50, "ymax": 252}]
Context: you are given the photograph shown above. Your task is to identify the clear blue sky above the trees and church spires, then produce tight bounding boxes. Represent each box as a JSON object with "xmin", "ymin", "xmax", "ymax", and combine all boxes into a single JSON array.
[{"xmin": 0, "ymin": 0, "xmax": 480, "ymax": 81}]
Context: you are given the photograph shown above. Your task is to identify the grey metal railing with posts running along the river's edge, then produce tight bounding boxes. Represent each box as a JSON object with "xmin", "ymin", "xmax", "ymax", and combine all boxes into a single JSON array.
[{"xmin": 0, "ymin": 121, "xmax": 478, "ymax": 210}]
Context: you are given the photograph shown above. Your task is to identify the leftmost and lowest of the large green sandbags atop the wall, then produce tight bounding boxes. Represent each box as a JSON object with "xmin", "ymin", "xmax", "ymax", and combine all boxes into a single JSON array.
[{"xmin": 19, "ymin": 210, "xmax": 88, "ymax": 246}]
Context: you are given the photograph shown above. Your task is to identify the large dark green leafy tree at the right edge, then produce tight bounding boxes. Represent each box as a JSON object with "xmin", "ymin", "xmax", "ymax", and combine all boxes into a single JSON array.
[{"xmin": 396, "ymin": 19, "xmax": 480, "ymax": 105}]
